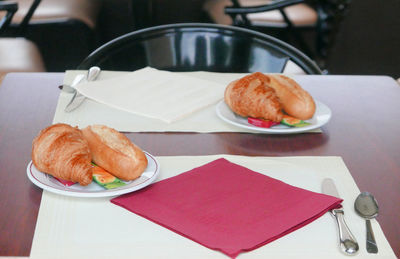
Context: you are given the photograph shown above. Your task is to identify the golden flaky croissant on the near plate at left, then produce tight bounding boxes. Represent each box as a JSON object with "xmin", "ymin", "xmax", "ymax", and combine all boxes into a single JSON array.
[{"xmin": 32, "ymin": 123, "xmax": 92, "ymax": 186}]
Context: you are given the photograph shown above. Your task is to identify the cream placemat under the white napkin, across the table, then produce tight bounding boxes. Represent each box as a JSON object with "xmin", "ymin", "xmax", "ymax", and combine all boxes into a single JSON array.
[{"xmin": 53, "ymin": 70, "xmax": 321, "ymax": 133}]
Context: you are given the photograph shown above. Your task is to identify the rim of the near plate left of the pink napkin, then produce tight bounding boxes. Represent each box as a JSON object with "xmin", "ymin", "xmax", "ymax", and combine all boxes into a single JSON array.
[{"xmin": 26, "ymin": 151, "xmax": 160, "ymax": 198}]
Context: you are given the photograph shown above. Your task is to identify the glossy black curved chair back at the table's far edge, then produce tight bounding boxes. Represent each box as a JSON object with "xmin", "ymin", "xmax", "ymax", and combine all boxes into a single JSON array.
[{"xmin": 78, "ymin": 23, "xmax": 321, "ymax": 74}]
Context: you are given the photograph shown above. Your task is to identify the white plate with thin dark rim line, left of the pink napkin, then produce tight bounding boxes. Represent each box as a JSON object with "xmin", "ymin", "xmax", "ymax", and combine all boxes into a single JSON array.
[{"xmin": 26, "ymin": 152, "xmax": 160, "ymax": 197}]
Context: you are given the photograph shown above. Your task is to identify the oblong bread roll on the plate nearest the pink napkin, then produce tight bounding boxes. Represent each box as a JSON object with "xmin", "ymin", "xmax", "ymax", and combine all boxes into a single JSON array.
[{"xmin": 82, "ymin": 125, "xmax": 147, "ymax": 181}]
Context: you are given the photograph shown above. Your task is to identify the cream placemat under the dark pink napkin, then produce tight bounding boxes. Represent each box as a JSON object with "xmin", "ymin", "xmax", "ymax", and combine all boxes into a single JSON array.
[{"xmin": 31, "ymin": 155, "xmax": 396, "ymax": 258}]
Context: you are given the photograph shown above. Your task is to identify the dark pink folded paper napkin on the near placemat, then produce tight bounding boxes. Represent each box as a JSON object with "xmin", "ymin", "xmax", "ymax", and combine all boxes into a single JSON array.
[{"xmin": 111, "ymin": 158, "xmax": 342, "ymax": 258}]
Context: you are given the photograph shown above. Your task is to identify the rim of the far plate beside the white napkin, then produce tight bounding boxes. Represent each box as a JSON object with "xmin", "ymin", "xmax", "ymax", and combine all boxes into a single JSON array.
[{"xmin": 215, "ymin": 99, "xmax": 332, "ymax": 134}]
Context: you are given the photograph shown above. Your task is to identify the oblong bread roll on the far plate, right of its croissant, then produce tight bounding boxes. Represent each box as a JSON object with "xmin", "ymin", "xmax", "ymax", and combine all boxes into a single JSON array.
[{"xmin": 268, "ymin": 74, "xmax": 315, "ymax": 120}]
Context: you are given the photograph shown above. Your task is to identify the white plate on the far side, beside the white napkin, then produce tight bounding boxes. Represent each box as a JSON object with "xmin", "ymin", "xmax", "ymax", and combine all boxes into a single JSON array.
[{"xmin": 216, "ymin": 100, "xmax": 332, "ymax": 134}]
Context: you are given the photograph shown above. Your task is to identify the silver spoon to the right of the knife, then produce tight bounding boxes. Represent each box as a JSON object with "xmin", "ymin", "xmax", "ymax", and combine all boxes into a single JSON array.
[{"xmin": 354, "ymin": 192, "xmax": 379, "ymax": 254}]
